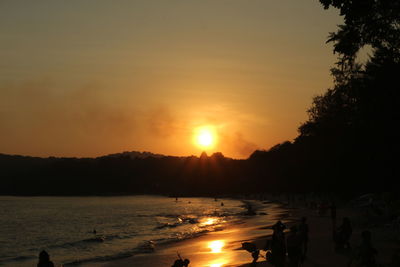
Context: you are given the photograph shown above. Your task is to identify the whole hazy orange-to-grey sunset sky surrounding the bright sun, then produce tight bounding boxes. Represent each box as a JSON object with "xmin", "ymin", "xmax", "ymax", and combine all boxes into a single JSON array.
[{"xmin": 0, "ymin": 0, "xmax": 342, "ymax": 158}]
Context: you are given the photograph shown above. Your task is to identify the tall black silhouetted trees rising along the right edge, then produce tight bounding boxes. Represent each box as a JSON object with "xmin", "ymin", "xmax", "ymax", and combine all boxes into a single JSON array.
[{"xmin": 296, "ymin": 0, "xmax": 400, "ymax": 190}]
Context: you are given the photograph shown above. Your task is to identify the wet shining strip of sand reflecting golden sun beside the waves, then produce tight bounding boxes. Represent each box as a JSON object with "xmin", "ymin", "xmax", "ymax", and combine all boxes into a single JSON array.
[{"xmin": 90, "ymin": 199, "xmax": 290, "ymax": 267}]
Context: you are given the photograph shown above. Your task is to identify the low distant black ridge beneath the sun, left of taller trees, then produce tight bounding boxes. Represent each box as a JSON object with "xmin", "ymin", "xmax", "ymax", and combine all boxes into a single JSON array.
[{"xmin": 0, "ymin": 153, "xmax": 246, "ymax": 195}]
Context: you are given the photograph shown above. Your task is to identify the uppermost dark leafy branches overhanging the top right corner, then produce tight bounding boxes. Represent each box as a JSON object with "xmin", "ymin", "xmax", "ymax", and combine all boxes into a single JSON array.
[{"xmin": 320, "ymin": 0, "xmax": 400, "ymax": 60}]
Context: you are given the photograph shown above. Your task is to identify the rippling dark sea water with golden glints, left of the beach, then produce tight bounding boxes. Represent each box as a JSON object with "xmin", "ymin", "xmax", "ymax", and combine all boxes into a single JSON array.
[{"xmin": 0, "ymin": 196, "xmax": 245, "ymax": 267}]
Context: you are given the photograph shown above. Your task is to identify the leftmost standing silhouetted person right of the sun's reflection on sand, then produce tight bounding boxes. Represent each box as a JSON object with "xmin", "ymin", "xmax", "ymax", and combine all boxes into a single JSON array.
[{"xmin": 271, "ymin": 221, "xmax": 286, "ymax": 267}]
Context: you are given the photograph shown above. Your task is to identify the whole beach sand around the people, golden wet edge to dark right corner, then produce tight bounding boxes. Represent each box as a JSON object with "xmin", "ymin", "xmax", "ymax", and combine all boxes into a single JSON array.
[{"xmin": 97, "ymin": 202, "xmax": 399, "ymax": 267}]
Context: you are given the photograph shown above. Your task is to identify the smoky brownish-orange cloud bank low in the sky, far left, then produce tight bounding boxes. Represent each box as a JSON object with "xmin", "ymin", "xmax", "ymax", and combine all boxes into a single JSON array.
[{"xmin": 0, "ymin": 80, "xmax": 136, "ymax": 155}]
